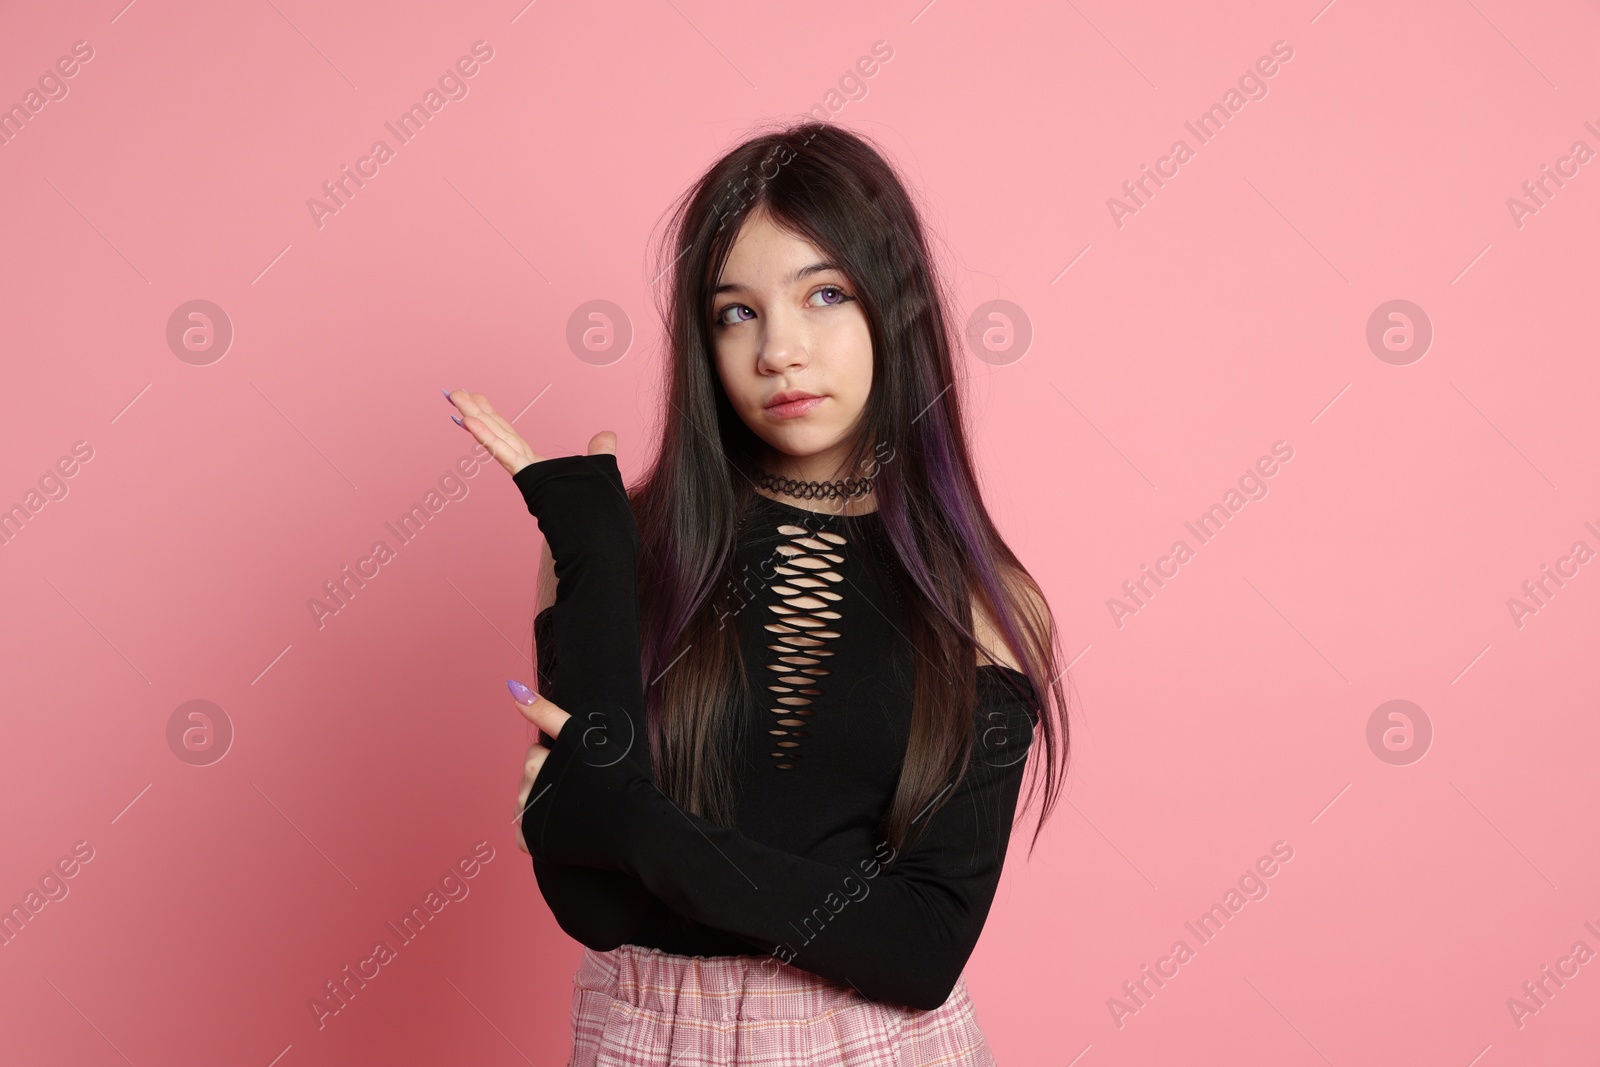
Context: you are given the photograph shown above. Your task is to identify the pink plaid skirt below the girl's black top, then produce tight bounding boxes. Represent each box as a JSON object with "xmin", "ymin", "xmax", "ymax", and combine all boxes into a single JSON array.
[{"xmin": 568, "ymin": 945, "xmax": 995, "ymax": 1067}]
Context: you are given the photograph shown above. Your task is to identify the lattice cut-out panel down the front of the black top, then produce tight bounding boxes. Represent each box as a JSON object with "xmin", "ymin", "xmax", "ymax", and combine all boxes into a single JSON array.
[{"xmin": 762, "ymin": 522, "xmax": 848, "ymax": 771}]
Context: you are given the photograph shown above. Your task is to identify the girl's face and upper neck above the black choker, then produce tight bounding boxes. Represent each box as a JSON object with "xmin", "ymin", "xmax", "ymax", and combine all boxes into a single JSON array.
[{"xmin": 710, "ymin": 210, "xmax": 872, "ymax": 480}]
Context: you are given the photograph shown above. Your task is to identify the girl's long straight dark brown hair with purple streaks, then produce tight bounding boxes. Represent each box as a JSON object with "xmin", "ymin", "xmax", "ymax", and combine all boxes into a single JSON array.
[{"xmin": 629, "ymin": 122, "xmax": 1067, "ymax": 853}]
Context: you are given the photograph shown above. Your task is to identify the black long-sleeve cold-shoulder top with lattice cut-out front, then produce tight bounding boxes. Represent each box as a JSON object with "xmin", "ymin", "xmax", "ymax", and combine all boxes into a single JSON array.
[{"xmin": 514, "ymin": 454, "xmax": 1038, "ymax": 1009}]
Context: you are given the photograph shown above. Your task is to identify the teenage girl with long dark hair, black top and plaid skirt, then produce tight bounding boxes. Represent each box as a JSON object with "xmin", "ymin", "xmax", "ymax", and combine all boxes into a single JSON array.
[{"xmin": 448, "ymin": 123, "xmax": 1067, "ymax": 1067}]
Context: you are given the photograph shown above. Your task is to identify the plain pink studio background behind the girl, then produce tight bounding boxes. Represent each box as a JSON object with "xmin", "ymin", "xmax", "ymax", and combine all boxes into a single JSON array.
[{"xmin": 0, "ymin": 0, "xmax": 1600, "ymax": 1067}]
